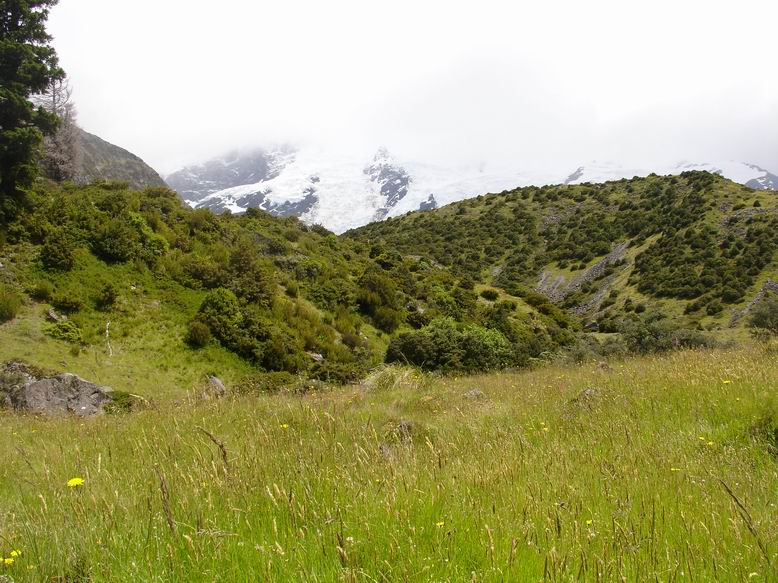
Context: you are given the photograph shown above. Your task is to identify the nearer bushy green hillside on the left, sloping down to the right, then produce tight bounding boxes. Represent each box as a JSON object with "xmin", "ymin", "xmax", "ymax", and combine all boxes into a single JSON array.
[{"xmin": 0, "ymin": 182, "xmax": 576, "ymax": 398}]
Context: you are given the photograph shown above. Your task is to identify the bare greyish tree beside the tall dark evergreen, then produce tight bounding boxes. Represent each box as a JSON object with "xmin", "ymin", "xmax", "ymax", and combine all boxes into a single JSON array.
[{"xmin": 32, "ymin": 77, "xmax": 81, "ymax": 182}]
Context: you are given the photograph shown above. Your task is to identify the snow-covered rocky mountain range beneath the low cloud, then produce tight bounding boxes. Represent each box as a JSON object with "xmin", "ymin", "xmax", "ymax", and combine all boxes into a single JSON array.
[{"xmin": 167, "ymin": 146, "xmax": 778, "ymax": 233}]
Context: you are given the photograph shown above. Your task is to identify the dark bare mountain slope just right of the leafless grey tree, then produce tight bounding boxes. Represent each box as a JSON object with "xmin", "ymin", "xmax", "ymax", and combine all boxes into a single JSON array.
[{"xmin": 78, "ymin": 128, "xmax": 165, "ymax": 188}]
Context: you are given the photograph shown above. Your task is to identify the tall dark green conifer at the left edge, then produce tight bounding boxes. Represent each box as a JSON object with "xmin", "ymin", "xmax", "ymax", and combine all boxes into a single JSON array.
[{"xmin": 0, "ymin": 0, "xmax": 64, "ymax": 214}]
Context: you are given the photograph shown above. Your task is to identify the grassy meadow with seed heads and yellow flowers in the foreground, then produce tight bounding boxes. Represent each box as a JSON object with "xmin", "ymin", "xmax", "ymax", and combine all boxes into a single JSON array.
[{"xmin": 0, "ymin": 350, "xmax": 778, "ymax": 581}]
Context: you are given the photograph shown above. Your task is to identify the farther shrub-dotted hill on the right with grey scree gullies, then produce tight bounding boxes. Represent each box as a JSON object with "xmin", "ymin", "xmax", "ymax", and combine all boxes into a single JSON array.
[{"xmin": 347, "ymin": 172, "xmax": 778, "ymax": 332}]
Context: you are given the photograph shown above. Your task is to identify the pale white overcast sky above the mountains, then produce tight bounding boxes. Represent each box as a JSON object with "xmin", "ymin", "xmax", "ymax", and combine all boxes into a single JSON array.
[{"xmin": 49, "ymin": 0, "xmax": 778, "ymax": 174}]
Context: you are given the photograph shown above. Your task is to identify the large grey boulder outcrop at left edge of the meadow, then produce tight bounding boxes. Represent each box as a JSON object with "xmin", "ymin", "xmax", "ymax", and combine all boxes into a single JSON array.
[{"xmin": 0, "ymin": 362, "xmax": 113, "ymax": 417}]
